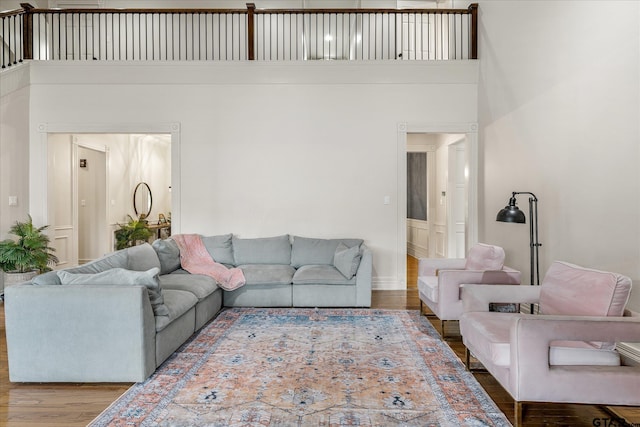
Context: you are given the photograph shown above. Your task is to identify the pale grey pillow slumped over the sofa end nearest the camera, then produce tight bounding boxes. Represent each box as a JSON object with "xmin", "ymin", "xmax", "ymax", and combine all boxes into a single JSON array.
[{"xmin": 57, "ymin": 267, "xmax": 169, "ymax": 316}]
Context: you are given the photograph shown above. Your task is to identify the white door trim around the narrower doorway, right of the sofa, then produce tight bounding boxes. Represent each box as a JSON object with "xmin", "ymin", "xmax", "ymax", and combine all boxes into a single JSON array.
[{"xmin": 396, "ymin": 122, "xmax": 479, "ymax": 289}]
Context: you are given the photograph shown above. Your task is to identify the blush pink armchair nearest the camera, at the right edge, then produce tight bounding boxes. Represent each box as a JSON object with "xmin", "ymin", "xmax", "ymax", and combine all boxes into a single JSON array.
[{"xmin": 460, "ymin": 262, "xmax": 640, "ymax": 425}]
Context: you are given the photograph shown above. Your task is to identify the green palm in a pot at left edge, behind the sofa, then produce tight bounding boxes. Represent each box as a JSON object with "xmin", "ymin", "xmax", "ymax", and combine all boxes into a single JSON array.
[{"xmin": 0, "ymin": 216, "xmax": 58, "ymax": 286}]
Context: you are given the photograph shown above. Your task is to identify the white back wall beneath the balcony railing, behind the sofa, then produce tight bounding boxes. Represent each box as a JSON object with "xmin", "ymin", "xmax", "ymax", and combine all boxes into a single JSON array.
[{"xmin": 12, "ymin": 62, "xmax": 477, "ymax": 287}]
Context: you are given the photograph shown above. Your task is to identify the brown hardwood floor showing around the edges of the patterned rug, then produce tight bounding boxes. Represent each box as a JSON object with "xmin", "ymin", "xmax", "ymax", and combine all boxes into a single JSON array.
[{"xmin": 0, "ymin": 257, "xmax": 640, "ymax": 427}]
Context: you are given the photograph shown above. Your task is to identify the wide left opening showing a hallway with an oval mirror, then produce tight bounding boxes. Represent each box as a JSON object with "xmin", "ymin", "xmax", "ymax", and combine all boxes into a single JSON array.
[{"xmin": 47, "ymin": 133, "xmax": 172, "ymax": 267}]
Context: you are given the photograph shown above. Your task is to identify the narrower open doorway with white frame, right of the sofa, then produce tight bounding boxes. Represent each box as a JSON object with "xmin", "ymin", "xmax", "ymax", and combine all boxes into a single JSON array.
[{"xmin": 398, "ymin": 124, "xmax": 478, "ymax": 288}]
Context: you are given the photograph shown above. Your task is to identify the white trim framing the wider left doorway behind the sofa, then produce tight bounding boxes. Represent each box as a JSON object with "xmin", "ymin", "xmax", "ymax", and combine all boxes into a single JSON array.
[{"xmin": 29, "ymin": 123, "xmax": 182, "ymax": 247}]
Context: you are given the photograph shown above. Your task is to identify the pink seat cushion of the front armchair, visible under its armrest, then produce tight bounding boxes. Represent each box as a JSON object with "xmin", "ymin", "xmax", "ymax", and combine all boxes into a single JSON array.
[{"xmin": 461, "ymin": 312, "xmax": 620, "ymax": 367}]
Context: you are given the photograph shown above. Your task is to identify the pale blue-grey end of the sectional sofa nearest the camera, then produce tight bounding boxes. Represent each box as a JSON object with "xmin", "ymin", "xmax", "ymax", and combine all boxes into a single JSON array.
[{"xmin": 5, "ymin": 285, "xmax": 156, "ymax": 382}]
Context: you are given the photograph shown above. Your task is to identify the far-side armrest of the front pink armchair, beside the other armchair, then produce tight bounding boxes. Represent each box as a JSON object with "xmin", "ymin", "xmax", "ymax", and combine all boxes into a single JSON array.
[{"xmin": 461, "ymin": 283, "xmax": 540, "ymax": 312}]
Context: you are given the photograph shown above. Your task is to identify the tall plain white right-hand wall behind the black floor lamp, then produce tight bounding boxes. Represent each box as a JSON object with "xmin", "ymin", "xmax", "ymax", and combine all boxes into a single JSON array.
[{"xmin": 479, "ymin": 0, "xmax": 640, "ymax": 309}]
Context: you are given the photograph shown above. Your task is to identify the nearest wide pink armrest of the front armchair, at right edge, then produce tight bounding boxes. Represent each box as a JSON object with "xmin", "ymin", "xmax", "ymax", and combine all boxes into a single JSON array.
[{"xmin": 509, "ymin": 315, "xmax": 640, "ymax": 405}]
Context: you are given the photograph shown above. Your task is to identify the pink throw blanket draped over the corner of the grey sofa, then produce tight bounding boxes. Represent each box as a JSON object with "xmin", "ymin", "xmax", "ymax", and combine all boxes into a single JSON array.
[{"xmin": 171, "ymin": 234, "xmax": 246, "ymax": 291}]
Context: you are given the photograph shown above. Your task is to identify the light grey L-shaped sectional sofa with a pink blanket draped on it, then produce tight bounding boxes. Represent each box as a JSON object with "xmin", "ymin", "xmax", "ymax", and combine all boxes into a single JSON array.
[{"xmin": 5, "ymin": 234, "xmax": 372, "ymax": 382}]
